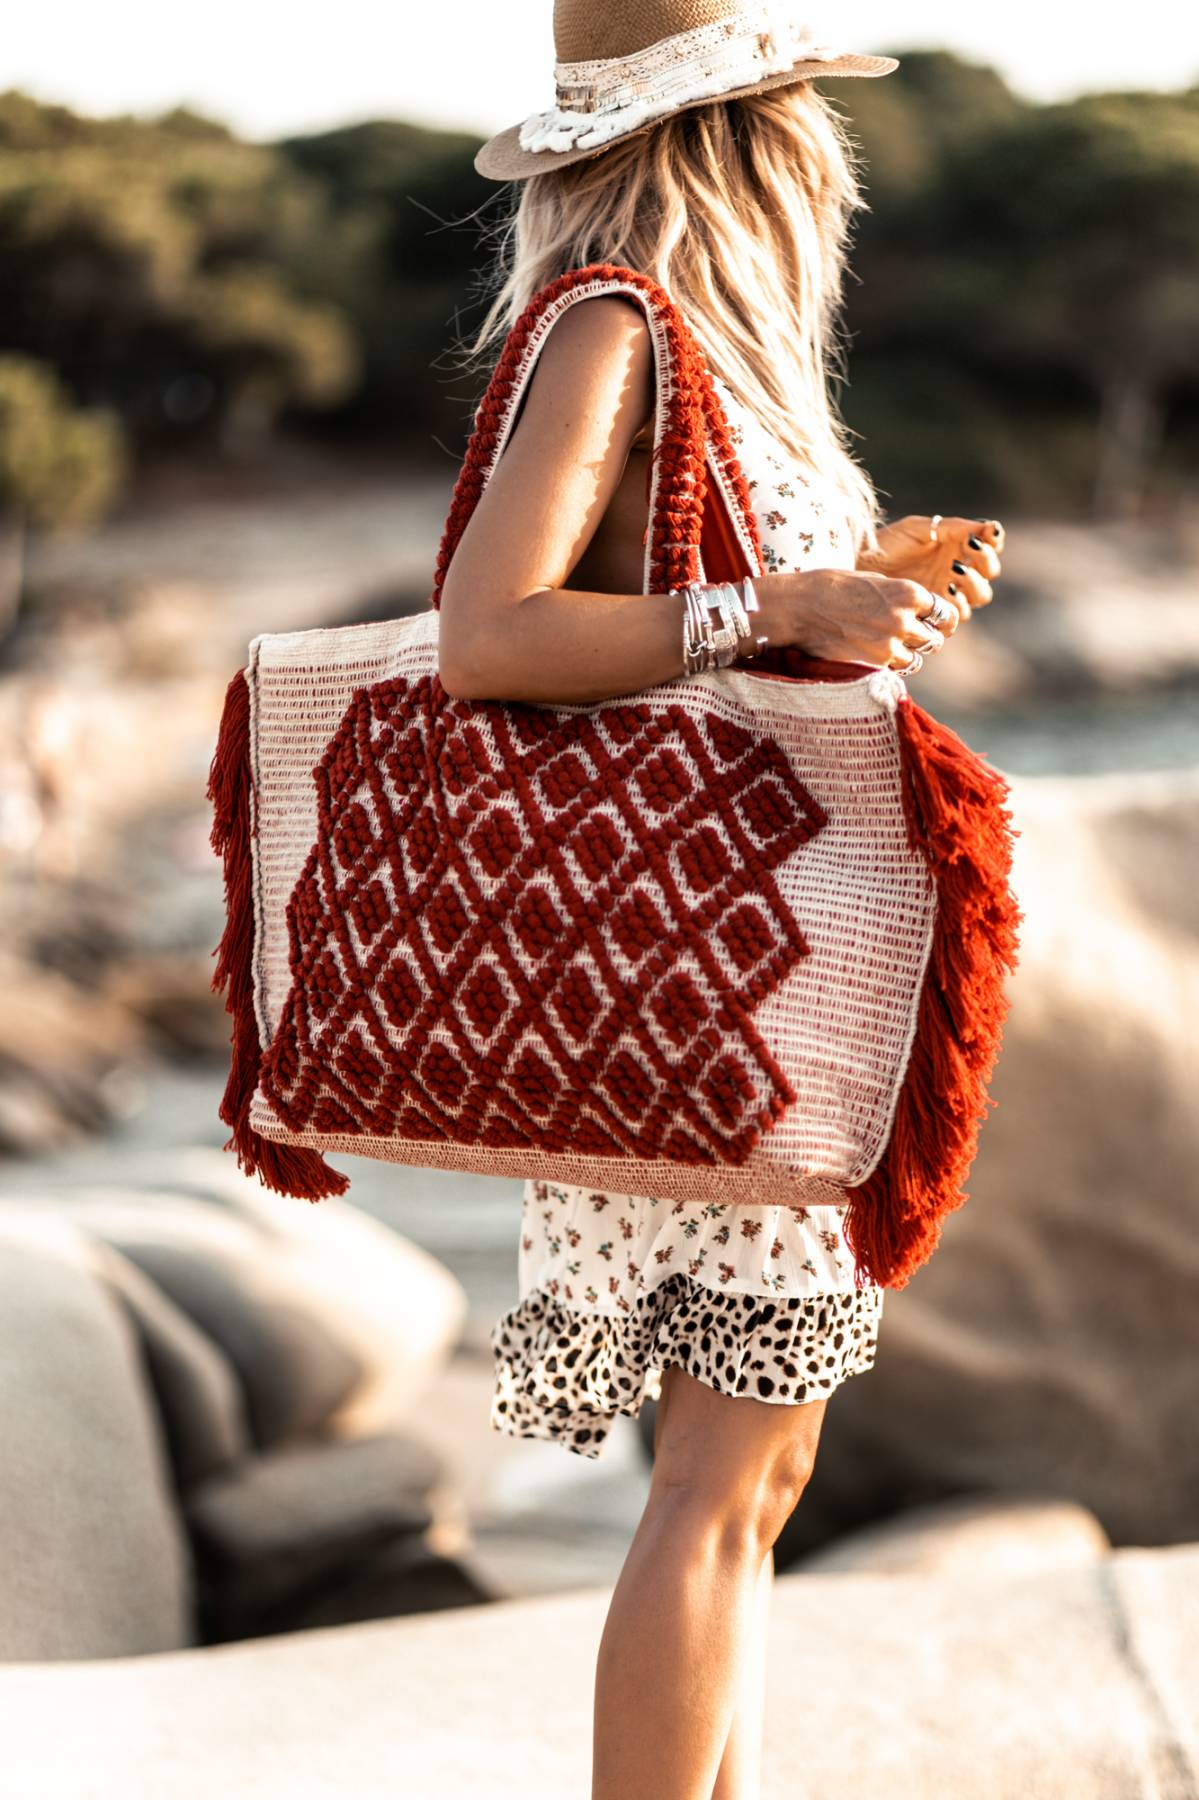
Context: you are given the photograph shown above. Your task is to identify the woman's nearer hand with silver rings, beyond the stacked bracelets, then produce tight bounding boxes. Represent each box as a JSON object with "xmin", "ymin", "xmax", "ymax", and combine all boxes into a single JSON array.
[{"xmin": 766, "ymin": 569, "xmax": 958, "ymax": 671}]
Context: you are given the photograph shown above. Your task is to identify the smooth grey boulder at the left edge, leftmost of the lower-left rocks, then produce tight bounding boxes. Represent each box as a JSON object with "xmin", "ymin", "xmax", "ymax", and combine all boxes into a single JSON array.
[{"xmin": 0, "ymin": 1206, "xmax": 194, "ymax": 1656}]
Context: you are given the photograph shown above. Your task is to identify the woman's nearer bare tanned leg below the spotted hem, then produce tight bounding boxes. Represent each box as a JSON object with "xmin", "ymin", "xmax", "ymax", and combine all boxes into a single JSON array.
[{"xmin": 592, "ymin": 1366, "xmax": 828, "ymax": 1800}]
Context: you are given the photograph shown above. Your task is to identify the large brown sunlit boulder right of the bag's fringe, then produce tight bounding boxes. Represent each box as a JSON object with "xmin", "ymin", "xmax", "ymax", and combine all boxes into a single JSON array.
[{"xmin": 781, "ymin": 774, "xmax": 1199, "ymax": 1557}]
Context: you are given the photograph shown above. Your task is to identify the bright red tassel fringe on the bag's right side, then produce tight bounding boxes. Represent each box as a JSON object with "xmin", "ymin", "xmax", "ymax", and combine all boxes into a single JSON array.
[{"xmin": 846, "ymin": 698, "xmax": 1021, "ymax": 1287}]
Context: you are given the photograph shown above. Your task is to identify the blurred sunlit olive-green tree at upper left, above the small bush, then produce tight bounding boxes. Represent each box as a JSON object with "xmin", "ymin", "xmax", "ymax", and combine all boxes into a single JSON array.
[{"xmin": 0, "ymin": 92, "xmax": 364, "ymax": 450}]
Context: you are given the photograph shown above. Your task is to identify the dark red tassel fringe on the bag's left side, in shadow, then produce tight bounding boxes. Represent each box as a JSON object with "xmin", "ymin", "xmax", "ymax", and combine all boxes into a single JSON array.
[{"xmin": 209, "ymin": 670, "xmax": 349, "ymax": 1201}]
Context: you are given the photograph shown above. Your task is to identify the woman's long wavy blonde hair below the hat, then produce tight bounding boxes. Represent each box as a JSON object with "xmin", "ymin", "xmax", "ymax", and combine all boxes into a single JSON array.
[{"xmin": 468, "ymin": 81, "xmax": 880, "ymax": 553}]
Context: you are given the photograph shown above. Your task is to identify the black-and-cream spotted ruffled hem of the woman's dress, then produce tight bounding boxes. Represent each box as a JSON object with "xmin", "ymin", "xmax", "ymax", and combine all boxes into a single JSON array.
[{"xmin": 491, "ymin": 1273, "xmax": 884, "ymax": 1456}]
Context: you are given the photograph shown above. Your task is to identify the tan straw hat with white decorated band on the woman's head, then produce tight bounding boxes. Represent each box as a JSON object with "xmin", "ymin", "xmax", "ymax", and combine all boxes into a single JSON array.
[{"xmin": 475, "ymin": 0, "xmax": 898, "ymax": 182}]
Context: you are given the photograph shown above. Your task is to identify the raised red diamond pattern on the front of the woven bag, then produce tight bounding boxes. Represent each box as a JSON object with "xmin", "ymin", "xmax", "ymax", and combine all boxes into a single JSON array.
[{"xmin": 261, "ymin": 675, "xmax": 826, "ymax": 1165}]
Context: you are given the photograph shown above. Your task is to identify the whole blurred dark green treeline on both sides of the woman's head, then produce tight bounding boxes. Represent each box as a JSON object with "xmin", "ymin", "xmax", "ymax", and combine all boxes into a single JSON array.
[{"xmin": 0, "ymin": 72, "xmax": 1199, "ymax": 515}]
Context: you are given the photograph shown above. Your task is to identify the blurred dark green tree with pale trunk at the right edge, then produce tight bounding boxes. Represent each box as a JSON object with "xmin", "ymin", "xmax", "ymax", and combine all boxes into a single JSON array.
[{"xmin": 942, "ymin": 94, "xmax": 1199, "ymax": 518}]
